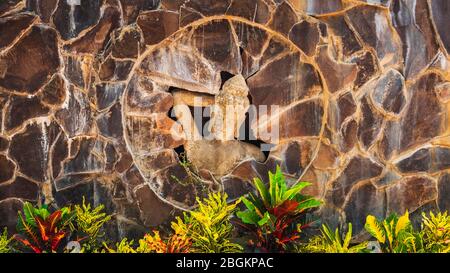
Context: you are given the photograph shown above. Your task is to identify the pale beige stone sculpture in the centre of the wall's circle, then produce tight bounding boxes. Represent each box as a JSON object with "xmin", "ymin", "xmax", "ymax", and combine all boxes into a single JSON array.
[{"xmin": 174, "ymin": 75, "xmax": 265, "ymax": 177}]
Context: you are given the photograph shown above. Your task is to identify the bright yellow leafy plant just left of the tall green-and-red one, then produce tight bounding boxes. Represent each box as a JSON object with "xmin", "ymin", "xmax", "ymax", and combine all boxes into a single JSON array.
[{"xmin": 172, "ymin": 192, "xmax": 242, "ymax": 253}]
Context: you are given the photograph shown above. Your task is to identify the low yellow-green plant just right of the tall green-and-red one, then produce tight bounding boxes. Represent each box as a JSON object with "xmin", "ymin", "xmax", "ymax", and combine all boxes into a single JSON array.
[{"xmin": 300, "ymin": 223, "xmax": 368, "ymax": 253}]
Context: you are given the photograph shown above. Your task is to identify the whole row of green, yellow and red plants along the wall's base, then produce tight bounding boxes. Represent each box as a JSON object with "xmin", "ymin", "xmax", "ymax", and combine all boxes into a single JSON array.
[{"xmin": 0, "ymin": 167, "xmax": 450, "ymax": 253}]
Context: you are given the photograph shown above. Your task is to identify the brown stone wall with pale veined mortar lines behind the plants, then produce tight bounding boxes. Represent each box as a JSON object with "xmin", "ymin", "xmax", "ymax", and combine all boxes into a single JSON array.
[{"xmin": 0, "ymin": 0, "xmax": 450, "ymax": 236}]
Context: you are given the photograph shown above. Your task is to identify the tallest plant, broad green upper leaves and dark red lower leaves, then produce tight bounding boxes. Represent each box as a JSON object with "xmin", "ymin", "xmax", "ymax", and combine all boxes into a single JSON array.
[{"xmin": 237, "ymin": 167, "xmax": 321, "ymax": 252}]
